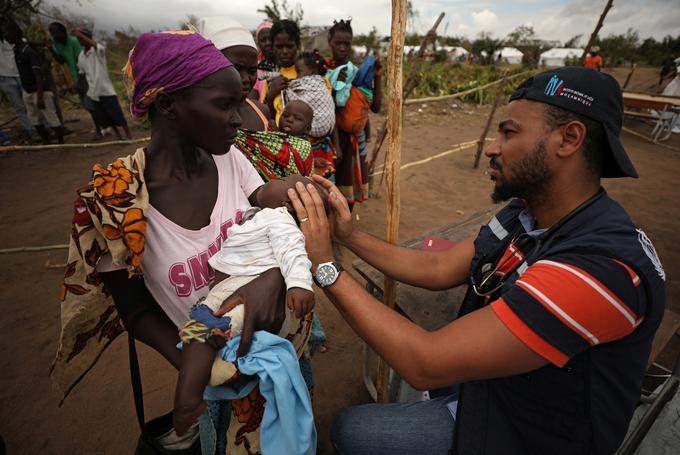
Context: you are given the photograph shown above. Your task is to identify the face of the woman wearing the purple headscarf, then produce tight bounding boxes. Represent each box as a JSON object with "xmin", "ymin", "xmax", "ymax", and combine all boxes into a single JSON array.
[{"xmin": 173, "ymin": 67, "xmax": 242, "ymax": 155}]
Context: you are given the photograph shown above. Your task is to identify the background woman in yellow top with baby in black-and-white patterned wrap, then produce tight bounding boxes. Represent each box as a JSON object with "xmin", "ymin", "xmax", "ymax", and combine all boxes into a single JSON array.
[{"xmin": 260, "ymin": 19, "xmax": 300, "ymax": 125}]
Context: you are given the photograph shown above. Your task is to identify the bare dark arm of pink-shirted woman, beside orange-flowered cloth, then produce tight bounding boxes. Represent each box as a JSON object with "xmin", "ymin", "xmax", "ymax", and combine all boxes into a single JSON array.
[{"xmin": 100, "ymin": 270, "xmax": 181, "ymax": 369}]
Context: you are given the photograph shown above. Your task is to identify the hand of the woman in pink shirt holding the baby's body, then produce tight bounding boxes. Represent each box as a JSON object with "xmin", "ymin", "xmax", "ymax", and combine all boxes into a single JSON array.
[{"xmin": 213, "ymin": 269, "xmax": 286, "ymax": 357}]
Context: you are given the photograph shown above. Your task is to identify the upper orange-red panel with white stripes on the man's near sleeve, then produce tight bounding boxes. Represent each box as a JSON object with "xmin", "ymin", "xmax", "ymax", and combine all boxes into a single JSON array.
[{"xmin": 517, "ymin": 260, "xmax": 637, "ymax": 344}]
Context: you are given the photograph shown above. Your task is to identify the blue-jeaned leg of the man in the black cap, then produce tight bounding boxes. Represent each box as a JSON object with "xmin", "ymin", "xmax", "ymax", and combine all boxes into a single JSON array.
[{"xmin": 331, "ymin": 396, "xmax": 457, "ymax": 455}]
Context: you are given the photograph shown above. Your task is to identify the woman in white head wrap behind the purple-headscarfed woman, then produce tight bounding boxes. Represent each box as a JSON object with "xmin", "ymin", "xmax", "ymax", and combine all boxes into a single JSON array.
[{"xmin": 196, "ymin": 16, "xmax": 271, "ymax": 131}]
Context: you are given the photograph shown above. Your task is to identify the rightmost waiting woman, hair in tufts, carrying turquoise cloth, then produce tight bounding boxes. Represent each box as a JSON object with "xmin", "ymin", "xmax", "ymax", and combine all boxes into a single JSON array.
[{"xmin": 327, "ymin": 20, "xmax": 382, "ymax": 210}]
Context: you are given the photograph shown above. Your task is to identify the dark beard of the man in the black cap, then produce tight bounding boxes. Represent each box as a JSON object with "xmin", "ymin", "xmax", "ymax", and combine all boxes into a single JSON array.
[{"xmin": 491, "ymin": 140, "xmax": 552, "ymax": 203}]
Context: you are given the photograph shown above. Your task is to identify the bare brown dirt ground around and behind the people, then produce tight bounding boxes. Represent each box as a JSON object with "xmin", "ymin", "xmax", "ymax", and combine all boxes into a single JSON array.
[{"xmin": 0, "ymin": 66, "xmax": 680, "ymax": 454}]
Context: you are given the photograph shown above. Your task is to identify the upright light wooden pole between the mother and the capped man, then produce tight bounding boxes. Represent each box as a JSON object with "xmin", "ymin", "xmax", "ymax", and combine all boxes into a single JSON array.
[{"xmin": 377, "ymin": 0, "xmax": 406, "ymax": 403}]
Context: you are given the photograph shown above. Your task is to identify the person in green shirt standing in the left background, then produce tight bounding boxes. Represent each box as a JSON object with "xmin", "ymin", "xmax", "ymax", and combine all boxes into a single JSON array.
[{"xmin": 48, "ymin": 22, "xmax": 103, "ymax": 140}]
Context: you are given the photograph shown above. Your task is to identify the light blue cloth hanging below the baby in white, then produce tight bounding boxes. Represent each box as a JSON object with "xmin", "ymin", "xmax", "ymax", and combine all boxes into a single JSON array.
[{"xmin": 203, "ymin": 331, "xmax": 316, "ymax": 455}]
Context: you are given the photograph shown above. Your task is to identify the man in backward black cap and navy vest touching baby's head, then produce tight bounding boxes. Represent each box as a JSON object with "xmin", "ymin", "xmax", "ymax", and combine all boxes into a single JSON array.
[{"xmin": 289, "ymin": 67, "xmax": 665, "ymax": 454}]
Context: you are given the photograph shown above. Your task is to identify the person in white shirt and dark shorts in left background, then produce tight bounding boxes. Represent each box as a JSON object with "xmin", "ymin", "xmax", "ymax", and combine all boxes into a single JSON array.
[{"xmin": 73, "ymin": 28, "xmax": 132, "ymax": 141}]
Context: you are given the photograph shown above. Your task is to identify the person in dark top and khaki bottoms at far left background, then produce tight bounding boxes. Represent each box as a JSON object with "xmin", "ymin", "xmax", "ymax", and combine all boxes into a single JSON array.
[{"xmin": 4, "ymin": 22, "xmax": 64, "ymax": 144}]
